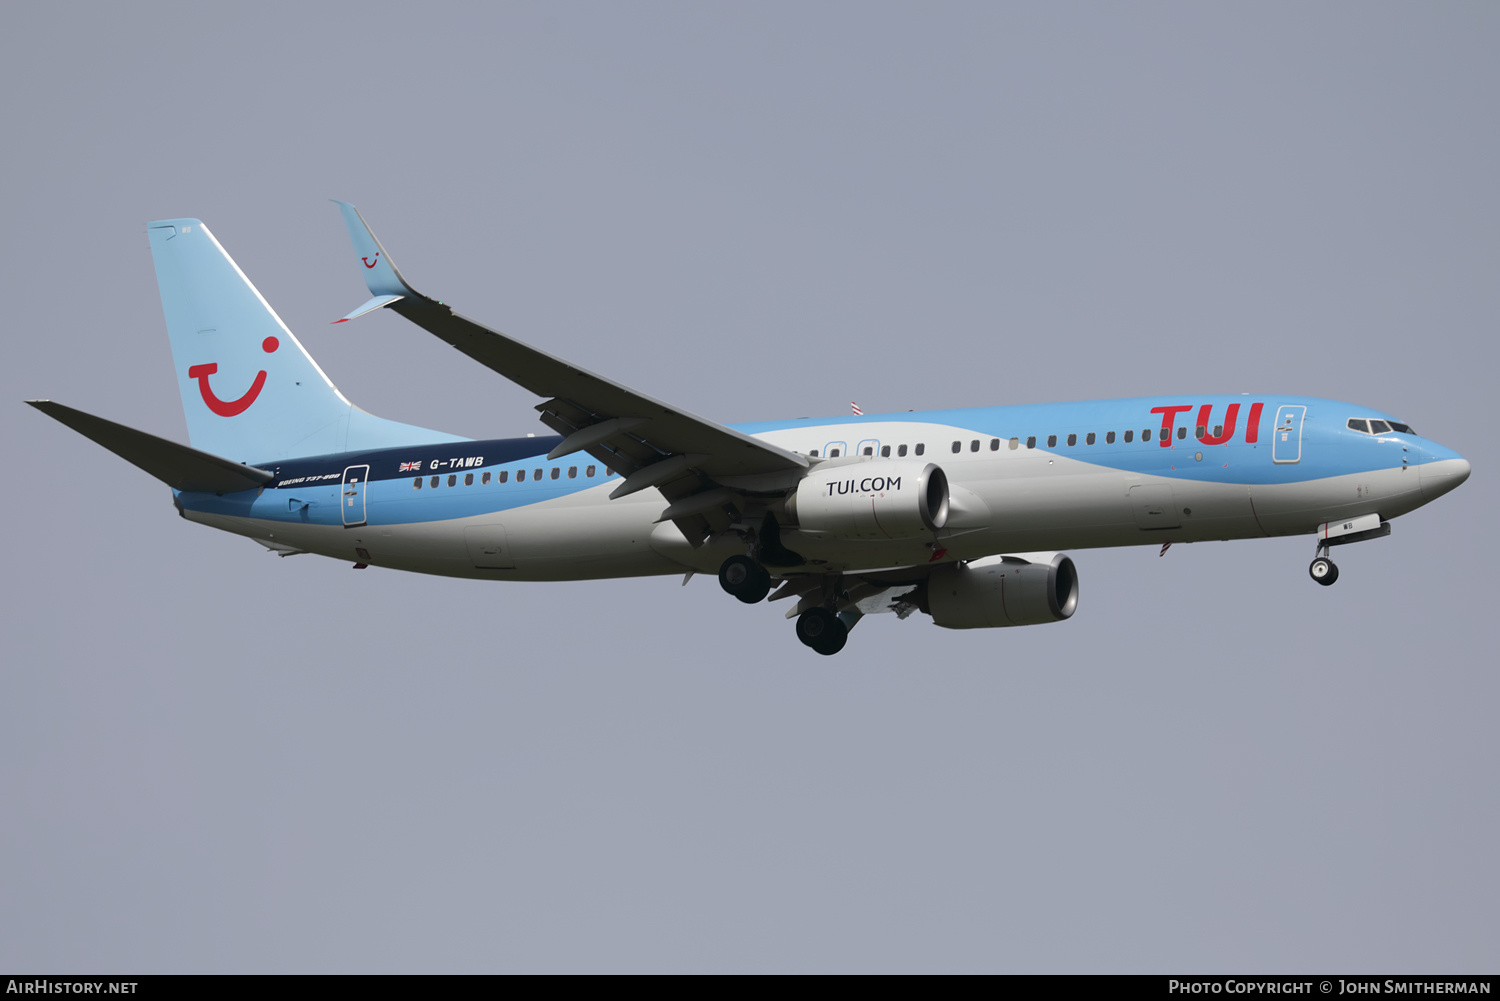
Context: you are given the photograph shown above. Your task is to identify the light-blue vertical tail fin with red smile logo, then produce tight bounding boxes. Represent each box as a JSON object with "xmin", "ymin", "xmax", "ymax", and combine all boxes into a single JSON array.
[{"xmin": 147, "ymin": 219, "xmax": 464, "ymax": 462}]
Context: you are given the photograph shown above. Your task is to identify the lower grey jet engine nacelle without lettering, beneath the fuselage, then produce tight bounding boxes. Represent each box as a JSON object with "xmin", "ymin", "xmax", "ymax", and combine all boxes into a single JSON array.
[{"xmin": 927, "ymin": 552, "xmax": 1079, "ymax": 629}]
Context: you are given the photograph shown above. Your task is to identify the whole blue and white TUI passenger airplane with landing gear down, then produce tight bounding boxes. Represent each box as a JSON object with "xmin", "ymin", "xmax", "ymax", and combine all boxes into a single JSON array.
[{"xmin": 27, "ymin": 201, "xmax": 1470, "ymax": 654}]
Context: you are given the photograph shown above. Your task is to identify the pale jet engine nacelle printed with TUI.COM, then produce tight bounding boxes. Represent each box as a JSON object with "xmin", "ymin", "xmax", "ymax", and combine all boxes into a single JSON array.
[{"xmin": 788, "ymin": 461, "xmax": 948, "ymax": 539}]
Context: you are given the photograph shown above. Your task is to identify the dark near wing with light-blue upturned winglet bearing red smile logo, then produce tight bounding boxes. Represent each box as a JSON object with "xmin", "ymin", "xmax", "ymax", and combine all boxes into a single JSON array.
[{"xmin": 335, "ymin": 201, "xmax": 809, "ymax": 545}]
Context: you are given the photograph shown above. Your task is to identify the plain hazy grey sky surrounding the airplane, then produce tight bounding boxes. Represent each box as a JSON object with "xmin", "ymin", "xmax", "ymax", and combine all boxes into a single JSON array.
[{"xmin": 0, "ymin": 3, "xmax": 1500, "ymax": 972}]
